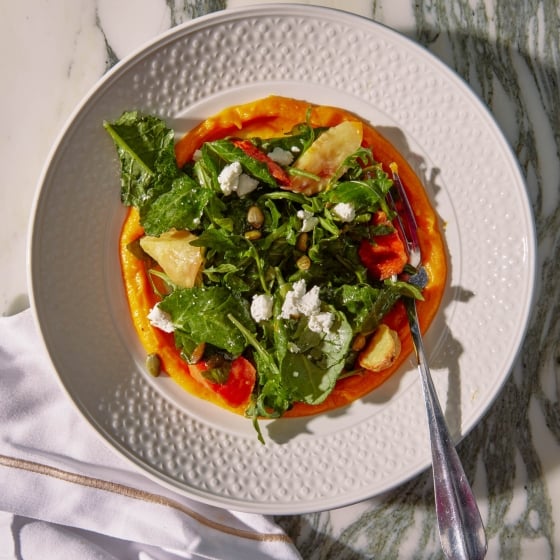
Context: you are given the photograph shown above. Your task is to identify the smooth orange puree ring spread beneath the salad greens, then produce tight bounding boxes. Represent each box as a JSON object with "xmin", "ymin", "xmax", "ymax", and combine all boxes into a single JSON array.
[{"xmin": 120, "ymin": 96, "xmax": 447, "ymax": 417}]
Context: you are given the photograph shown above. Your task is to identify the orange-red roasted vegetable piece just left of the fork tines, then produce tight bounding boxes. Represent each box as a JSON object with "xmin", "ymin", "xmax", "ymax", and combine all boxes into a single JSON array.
[{"xmin": 358, "ymin": 211, "xmax": 407, "ymax": 280}]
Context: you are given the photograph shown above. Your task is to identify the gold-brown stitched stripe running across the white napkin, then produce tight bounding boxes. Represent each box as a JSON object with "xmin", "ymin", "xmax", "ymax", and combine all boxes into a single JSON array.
[{"xmin": 0, "ymin": 455, "xmax": 291, "ymax": 542}]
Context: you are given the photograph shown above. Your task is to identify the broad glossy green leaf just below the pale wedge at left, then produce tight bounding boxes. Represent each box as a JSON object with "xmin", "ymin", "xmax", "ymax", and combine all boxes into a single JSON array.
[{"xmin": 159, "ymin": 286, "xmax": 255, "ymax": 356}]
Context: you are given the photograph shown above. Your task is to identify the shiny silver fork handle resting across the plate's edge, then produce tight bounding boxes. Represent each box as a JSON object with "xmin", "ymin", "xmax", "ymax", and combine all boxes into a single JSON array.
[{"xmin": 405, "ymin": 298, "xmax": 487, "ymax": 560}]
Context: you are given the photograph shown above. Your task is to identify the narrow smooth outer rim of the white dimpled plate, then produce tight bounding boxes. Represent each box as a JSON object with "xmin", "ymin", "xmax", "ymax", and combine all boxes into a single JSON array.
[{"xmin": 27, "ymin": 4, "xmax": 536, "ymax": 514}]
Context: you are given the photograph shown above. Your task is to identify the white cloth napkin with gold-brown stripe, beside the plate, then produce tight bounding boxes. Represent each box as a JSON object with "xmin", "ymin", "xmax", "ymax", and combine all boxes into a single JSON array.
[{"xmin": 0, "ymin": 310, "xmax": 300, "ymax": 560}]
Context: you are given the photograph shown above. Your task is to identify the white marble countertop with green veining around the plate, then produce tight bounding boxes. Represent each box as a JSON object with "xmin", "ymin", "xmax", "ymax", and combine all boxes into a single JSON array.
[{"xmin": 0, "ymin": 0, "xmax": 560, "ymax": 559}]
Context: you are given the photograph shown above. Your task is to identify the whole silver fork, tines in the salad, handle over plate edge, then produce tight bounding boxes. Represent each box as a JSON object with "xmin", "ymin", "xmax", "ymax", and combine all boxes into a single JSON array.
[{"xmin": 389, "ymin": 167, "xmax": 487, "ymax": 560}]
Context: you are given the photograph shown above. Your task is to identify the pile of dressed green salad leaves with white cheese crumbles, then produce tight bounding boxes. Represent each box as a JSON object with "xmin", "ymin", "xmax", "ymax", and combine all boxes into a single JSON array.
[{"xmin": 104, "ymin": 111, "xmax": 422, "ymax": 442}]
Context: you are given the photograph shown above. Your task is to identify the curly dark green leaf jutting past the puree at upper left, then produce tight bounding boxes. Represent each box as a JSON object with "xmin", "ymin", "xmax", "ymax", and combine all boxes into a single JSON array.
[{"xmin": 103, "ymin": 111, "xmax": 179, "ymax": 210}]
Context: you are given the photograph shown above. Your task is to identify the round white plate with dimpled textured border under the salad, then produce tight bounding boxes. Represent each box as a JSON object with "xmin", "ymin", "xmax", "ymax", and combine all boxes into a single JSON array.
[{"xmin": 30, "ymin": 5, "xmax": 535, "ymax": 514}]
